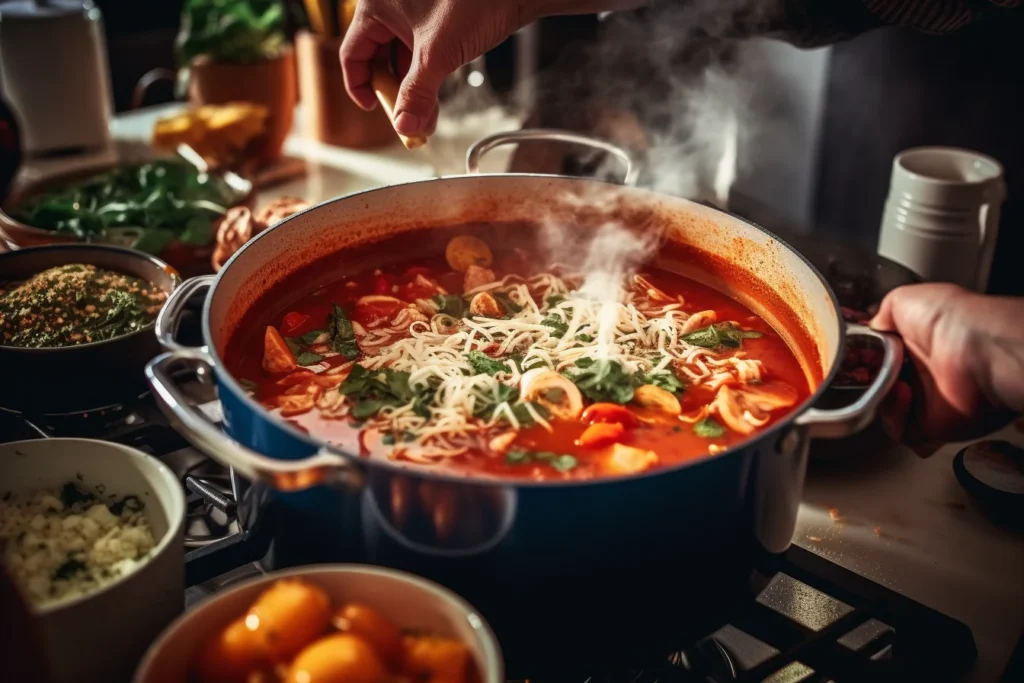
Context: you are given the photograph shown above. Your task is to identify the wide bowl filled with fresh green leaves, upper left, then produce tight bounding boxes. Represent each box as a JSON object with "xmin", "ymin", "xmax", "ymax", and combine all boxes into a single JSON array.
[{"xmin": 0, "ymin": 157, "xmax": 253, "ymax": 276}]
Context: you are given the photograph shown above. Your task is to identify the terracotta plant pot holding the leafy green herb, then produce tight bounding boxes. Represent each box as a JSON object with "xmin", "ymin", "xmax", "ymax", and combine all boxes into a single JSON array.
[{"xmin": 188, "ymin": 47, "xmax": 298, "ymax": 164}]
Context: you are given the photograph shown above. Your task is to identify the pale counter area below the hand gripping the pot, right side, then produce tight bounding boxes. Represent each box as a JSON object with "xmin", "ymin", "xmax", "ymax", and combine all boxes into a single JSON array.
[{"xmin": 794, "ymin": 422, "xmax": 1024, "ymax": 683}]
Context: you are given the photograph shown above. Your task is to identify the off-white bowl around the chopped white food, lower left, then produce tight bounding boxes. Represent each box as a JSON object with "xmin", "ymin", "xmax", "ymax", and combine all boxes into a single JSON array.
[{"xmin": 0, "ymin": 438, "xmax": 185, "ymax": 683}]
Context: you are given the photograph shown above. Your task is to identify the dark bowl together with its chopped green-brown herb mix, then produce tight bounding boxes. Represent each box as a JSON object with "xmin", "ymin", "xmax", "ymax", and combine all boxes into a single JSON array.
[{"xmin": 0, "ymin": 245, "xmax": 181, "ymax": 416}]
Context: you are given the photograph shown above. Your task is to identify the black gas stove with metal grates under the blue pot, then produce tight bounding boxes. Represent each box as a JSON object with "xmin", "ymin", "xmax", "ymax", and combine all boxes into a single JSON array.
[{"xmin": 0, "ymin": 378, "xmax": 991, "ymax": 683}]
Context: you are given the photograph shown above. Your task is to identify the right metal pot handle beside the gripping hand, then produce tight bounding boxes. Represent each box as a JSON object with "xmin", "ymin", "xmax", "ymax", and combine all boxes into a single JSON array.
[{"xmin": 796, "ymin": 325, "xmax": 903, "ymax": 438}]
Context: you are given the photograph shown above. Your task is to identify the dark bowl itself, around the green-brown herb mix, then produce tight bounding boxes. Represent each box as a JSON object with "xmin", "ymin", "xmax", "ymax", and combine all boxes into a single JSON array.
[{"xmin": 0, "ymin": 245, "xmax": 181, "ymax": 415}]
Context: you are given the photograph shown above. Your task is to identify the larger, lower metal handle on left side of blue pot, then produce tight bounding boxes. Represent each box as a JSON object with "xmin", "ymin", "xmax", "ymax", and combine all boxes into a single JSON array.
[{"xmin": 145, "ymin": 348, "xmax": 365, "ymax": 492}]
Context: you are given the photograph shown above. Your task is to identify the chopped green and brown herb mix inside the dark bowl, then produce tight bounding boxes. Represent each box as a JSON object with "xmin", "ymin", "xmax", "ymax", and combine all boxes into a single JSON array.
[{"xmin": 0, "ymin": 263, "xmax": 167, "ymax": 348}]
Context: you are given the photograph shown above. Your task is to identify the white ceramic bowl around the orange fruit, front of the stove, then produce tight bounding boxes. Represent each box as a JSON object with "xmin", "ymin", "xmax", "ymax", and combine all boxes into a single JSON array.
[{"xmin": 135, "ymin": 564, "xmax": 505, "ymax": 683}]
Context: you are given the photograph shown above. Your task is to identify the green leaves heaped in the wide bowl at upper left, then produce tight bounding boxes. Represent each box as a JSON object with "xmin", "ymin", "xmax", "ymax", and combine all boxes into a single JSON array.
[{"xmin": 13, "ymin": 159, "xmax": 241, "ymax": 248}]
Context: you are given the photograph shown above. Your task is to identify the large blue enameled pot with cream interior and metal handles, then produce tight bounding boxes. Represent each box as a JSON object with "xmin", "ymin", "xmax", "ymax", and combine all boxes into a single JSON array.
[{"xmin": 147, "ymin": 134, "xmax": 902, "ymax": 676}]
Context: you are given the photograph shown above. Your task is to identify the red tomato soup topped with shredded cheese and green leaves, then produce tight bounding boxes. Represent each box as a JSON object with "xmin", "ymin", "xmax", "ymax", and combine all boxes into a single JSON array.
[{"xmin": 226, "ymin": 237, "xmax": 810, "ymax": 481}]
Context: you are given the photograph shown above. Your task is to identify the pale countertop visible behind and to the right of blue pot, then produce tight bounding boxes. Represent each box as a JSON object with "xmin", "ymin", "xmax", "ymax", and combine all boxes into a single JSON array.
[{"xmin": 16, "ymin": 102, "xmax": 1024, "ymax": 683}]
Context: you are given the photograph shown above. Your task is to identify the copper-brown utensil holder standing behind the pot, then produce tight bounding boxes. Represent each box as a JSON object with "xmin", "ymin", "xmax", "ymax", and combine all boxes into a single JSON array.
[{"xmin": 295, "ymin": 31, "xmax": 397, "ymax": 150}]
